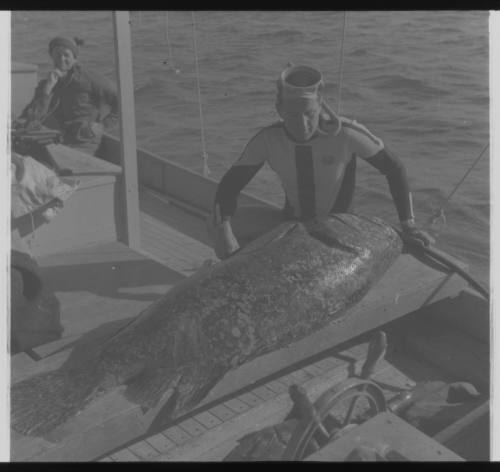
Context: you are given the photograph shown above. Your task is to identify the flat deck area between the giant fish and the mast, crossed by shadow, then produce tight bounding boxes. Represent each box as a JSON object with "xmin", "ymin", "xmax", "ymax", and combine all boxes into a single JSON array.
[{"xmin": 11, "ymin": 241, "xmax": 184, "ymax": 382}]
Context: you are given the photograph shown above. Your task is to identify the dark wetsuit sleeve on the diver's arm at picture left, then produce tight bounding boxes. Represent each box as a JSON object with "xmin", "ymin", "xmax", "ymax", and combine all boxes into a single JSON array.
[{"xmin": 214, "ymin": 133, "xmax": 267, "ymax": 224}]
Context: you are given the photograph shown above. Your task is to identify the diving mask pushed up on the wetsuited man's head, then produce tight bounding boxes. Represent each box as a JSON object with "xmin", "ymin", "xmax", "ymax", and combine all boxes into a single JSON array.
[{"xmin": 275, "ymin": 64, "xmax": 340, "ymax": 134}]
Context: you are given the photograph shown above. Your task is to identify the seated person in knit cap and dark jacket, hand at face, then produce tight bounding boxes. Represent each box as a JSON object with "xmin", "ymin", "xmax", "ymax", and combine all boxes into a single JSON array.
[{"xmin": 15, "ymin": 37, "xmax": 118, "ymax": 155}]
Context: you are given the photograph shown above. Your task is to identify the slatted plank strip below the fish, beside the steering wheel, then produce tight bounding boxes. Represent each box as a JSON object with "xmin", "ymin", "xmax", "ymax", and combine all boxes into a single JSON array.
[{"xmin": 107, "ymin": 343, "xmax": 385, "ymax": 461}]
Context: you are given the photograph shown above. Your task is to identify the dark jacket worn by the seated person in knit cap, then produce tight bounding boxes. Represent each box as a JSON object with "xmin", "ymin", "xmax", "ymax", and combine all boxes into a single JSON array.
[{"xmin": 20, "ymin": 63, "xmax": 118, "ymax": 145}]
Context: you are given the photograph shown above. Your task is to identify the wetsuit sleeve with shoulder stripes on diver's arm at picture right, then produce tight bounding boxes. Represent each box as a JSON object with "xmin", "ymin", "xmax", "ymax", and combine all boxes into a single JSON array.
[{"xmin": 343, "ymin": 121, "xmax": 413, "ymax": 221}]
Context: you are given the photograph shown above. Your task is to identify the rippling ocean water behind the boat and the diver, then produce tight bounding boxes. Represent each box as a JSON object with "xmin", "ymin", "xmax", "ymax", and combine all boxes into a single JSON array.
[{"xmin": 12, "ymin": 11, "xmax": 490, "ymax": 283}]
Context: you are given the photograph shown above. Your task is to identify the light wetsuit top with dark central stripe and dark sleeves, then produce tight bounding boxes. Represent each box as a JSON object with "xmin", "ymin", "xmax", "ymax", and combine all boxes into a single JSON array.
[{"xmin": 215, "ymin": 118, "xmax": 413, "ymax": 221}]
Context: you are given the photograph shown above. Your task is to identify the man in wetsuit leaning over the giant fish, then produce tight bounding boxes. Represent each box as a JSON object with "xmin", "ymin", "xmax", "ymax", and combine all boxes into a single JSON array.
[{"xmin": 210, "ymin": 66, "xmax": 433, "ymax": 259}]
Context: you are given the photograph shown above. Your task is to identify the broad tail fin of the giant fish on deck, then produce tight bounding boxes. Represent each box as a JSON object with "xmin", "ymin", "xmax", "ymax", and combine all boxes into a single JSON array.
[{"xmin": 11, "ymin": 371, "xmax": 99, "ymax": 436}]
